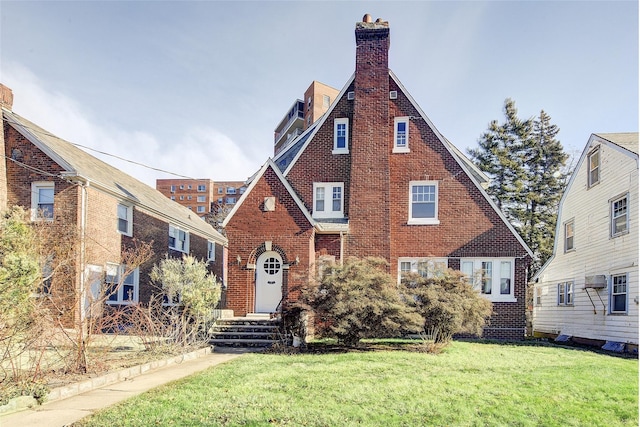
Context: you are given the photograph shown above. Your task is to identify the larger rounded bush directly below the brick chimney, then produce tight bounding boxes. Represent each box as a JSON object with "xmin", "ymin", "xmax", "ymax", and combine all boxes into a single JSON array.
[{"xmin": 301, "ymin": 257, "xmax": 424, "ymax": 346}]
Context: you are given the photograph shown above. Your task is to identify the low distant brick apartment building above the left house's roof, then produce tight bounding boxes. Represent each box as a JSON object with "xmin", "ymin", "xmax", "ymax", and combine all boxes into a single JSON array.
[{"xmin": 156, "ymin": 179, "xmax": 246, "ymax": 217}]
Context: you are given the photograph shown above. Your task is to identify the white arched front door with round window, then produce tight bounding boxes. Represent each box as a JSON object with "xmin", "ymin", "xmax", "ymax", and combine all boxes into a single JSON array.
[{"xmin": 255, "ymin": 251, "xmax": 282, "ymax": 313}]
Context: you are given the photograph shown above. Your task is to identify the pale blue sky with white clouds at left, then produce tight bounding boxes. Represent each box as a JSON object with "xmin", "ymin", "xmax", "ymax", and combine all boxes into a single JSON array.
[{"xmin": 0, "ymin": 0, "xmax": 639, "ymax": 187}]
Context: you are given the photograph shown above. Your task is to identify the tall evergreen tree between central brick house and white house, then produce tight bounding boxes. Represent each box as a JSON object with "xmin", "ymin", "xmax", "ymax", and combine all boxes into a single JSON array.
[{"xmin": 468, "ymin": 99, "xmax": 568, "ymax": 271}]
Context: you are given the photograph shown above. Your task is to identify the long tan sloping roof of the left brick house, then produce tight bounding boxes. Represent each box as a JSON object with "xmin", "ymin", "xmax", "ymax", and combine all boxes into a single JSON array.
[{"xmin": 2, "ymin": 108, "xmax": 227, "ymax": 244}]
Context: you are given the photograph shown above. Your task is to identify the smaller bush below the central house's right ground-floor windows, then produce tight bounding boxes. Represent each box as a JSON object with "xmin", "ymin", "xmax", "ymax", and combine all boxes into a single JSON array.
[{"xmin": 403, "ymin": 269, "xmax": 493, "ymax": 342}]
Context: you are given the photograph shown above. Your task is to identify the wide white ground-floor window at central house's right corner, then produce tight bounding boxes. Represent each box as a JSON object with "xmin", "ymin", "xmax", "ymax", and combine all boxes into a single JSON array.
[{"xmin": 460, "ymin": 258, "xmax": 516, "ymax": 302}]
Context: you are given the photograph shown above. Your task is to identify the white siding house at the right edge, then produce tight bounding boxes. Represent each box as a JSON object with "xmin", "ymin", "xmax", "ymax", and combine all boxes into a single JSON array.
[{"xmin": 533, "ymin": 133, "xmax": 639, "ymax": 352}]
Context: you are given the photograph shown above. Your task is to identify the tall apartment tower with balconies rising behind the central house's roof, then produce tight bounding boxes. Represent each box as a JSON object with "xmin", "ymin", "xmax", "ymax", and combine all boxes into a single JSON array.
[{"xmin": 273, "ymin": 80, "xmax": 340, "ymax": 155}]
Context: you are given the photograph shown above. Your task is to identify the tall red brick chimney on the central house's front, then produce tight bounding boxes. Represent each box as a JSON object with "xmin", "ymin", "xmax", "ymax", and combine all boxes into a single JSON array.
[{"xmin": 347, "ymin": 15, "xmax": 391, "ymax": 259}]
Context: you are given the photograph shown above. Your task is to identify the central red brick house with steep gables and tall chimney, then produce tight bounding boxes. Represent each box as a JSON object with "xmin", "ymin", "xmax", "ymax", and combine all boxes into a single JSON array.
[{"xmin": 223, "ymin": 15, "xmax": 532, "ymax": 339}]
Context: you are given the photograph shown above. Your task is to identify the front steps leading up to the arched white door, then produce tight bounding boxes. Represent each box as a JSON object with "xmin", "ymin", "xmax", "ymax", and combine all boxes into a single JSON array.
[{"xmin": 209, "ymin": 313, "xmax": 285, "ymax": 348}]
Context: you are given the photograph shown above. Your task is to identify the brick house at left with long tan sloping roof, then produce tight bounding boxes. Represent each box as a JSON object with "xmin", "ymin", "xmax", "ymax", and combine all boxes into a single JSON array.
[{"xmin": 0, "ymin": 84, "xmax": 227, "ymax": 322}]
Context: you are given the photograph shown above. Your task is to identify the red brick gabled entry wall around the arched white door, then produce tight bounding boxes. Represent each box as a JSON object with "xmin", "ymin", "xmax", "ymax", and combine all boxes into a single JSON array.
[{"xmin": 226, "ymin": 168, "xmax": 313, "ymax": 316}]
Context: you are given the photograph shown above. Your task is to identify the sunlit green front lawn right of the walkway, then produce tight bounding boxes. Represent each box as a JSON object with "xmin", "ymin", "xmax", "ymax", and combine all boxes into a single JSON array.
[{"xmin": 76, "ymin": 342, "xmax": 638, "ymax": 426}]
